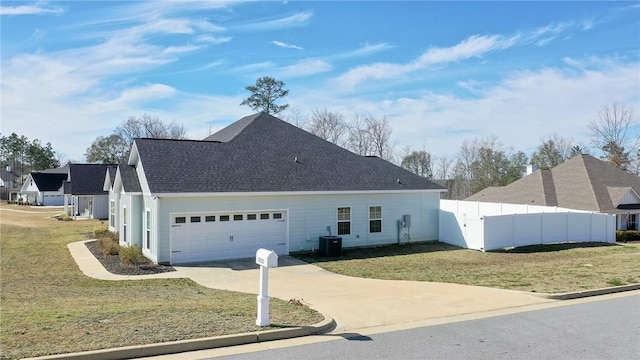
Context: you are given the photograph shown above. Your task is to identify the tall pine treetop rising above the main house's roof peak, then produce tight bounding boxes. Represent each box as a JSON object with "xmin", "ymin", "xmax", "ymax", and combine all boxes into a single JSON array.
[{"xmin": 240, "ymin": 76, "xmax": 289, "ymax": 114}]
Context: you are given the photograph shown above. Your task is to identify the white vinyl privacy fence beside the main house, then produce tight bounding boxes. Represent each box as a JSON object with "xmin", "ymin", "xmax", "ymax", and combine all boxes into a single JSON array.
[{"xmin": 439, "ymin": 200, "xmax": 616, "ymax": 251}]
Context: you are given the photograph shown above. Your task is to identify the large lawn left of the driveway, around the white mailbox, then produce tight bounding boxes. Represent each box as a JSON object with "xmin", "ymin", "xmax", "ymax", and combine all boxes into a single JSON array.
[{"xmin": 0, "ymin": 203, "xmax": 323, "ymax": 359}]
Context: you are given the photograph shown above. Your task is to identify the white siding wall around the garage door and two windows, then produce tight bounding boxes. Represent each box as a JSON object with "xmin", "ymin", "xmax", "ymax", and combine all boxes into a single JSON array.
[{"xmin": 153, "ymin": 191, "xmax": 440, "ymax": 263}]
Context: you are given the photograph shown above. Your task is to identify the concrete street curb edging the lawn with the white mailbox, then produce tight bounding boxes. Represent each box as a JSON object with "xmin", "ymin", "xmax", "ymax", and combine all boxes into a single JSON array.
[{"xmin": 24, "ymin": 314, "xmax": 336, "ymax": 360}]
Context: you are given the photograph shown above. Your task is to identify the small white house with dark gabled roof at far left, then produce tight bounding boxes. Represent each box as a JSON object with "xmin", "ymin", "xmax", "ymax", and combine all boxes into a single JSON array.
[{"xmin": 18, "ymin": 167, "xmax": 68, "ymax": 206}]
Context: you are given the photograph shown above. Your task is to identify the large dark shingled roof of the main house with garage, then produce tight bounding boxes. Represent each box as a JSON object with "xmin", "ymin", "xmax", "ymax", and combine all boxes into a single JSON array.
[{"xmin": 134, "ymin": 113, "xmax": 444, "ymax": 193}]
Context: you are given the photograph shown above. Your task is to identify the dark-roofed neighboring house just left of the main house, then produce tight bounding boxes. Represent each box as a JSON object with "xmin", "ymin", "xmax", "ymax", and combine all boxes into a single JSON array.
[{"xmin": 64, "ymin": 164, "xmax": 116, "ymax": 219}]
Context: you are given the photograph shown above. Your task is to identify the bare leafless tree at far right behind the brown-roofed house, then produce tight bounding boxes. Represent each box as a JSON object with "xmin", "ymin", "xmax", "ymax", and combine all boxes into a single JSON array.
[{"xmin": 589, "ymin": 102, "xmax": 640, "ymax": 170}]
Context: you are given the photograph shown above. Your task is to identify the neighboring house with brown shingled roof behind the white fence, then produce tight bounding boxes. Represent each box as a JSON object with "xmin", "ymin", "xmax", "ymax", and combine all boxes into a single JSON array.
[{"xmin": 466, "ymin": 154, "xmax": 640, "ymax": 230}]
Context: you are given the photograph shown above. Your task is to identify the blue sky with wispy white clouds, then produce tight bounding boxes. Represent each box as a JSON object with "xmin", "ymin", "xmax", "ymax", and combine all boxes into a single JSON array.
[{"xmin": 0, "ymin": 0, "xmax": 640, "ymax": 162}]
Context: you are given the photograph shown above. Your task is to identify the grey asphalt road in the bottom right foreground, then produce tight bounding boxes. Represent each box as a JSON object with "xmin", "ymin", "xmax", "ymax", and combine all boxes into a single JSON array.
[{"xmin": 216, "ymin": 295, "xmax": 640, "ymax": 360}]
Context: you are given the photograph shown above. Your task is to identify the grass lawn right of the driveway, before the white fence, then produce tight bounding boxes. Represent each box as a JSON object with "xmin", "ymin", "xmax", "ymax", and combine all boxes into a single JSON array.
[{"xmin": 294, "ymin": 242, "xmax": 640, "ymax": 293}]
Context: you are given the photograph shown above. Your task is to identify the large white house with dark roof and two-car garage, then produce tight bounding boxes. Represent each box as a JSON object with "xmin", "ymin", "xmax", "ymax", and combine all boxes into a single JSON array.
[{"xmin": 104, "ymin": 113, "xmax": 445, "ymax": 264}]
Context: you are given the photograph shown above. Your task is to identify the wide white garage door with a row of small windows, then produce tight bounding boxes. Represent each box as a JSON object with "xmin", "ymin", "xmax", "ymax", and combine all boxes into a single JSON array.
[{"xmin": 171, "ymin": 211, "xmax": 287, "ymax": 264}]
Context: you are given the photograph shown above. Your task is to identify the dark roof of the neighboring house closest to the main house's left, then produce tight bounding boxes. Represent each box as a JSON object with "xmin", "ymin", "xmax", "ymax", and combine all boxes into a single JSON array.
[{"xmin": 65, "ymin": 164, "xmax": 115, "ymax": 195}]
